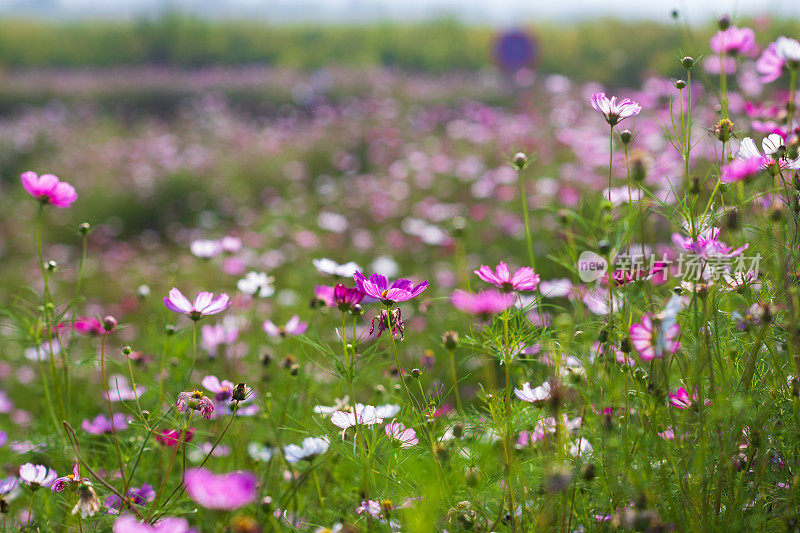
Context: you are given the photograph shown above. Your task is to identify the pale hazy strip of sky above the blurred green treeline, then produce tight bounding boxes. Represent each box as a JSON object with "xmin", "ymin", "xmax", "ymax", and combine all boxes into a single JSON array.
[{"xmin": 0, "ymin": 0, "xmax": 800, "ymax": 25}]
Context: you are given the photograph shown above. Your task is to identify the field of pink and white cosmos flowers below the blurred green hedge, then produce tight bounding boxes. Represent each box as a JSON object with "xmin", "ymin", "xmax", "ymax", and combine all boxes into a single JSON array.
[{"xmin": 0, "ymin": 12, "xmax": 800, "ymax": 533}]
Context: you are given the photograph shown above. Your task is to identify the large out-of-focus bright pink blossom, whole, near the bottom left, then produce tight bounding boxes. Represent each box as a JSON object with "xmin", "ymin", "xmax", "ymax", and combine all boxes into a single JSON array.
[{"xmin": 183, "ymin": 468, "xmax": 258, "ymax": 511}]
